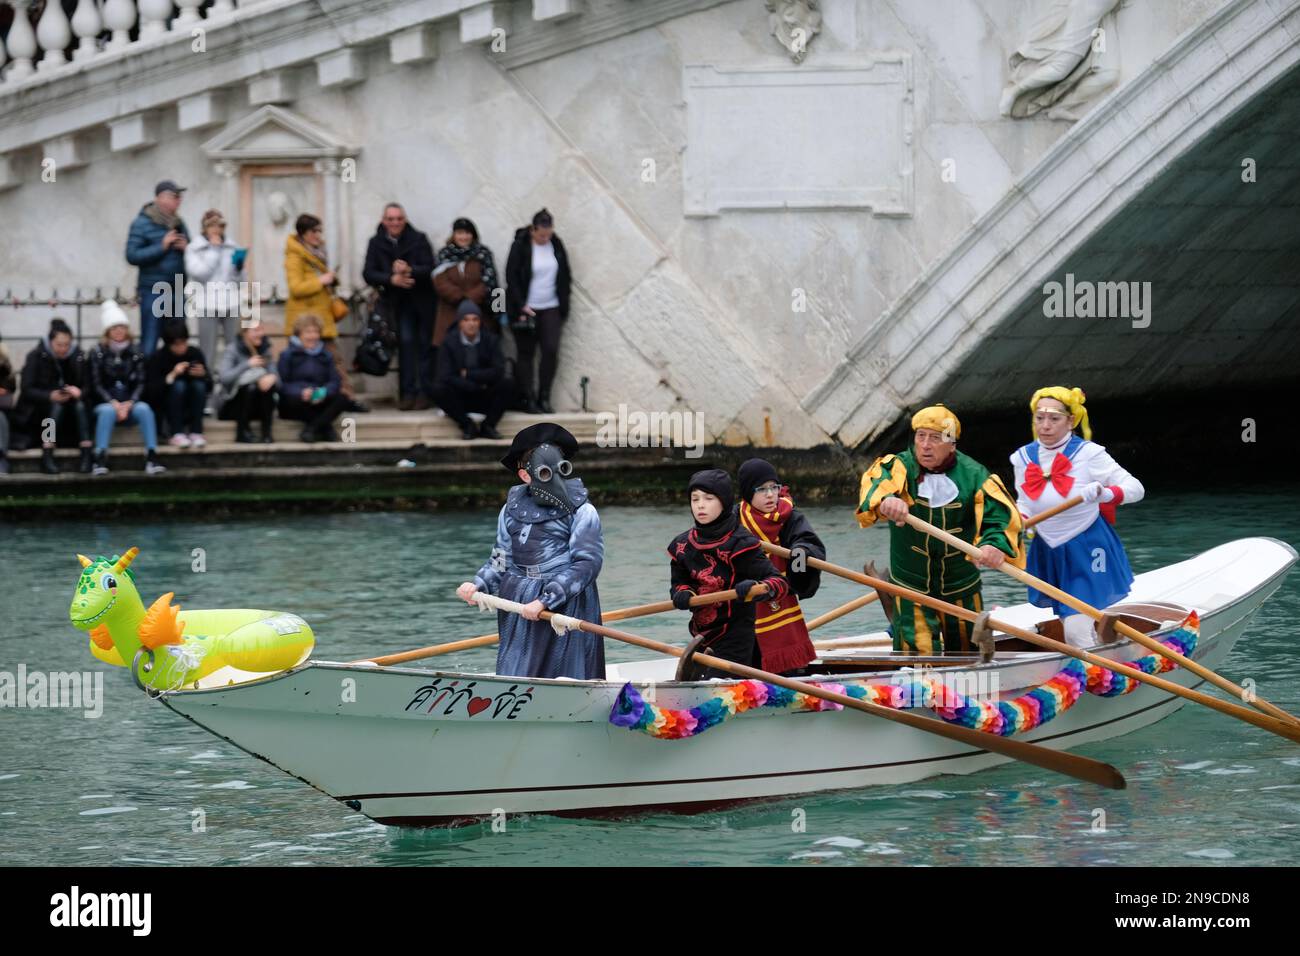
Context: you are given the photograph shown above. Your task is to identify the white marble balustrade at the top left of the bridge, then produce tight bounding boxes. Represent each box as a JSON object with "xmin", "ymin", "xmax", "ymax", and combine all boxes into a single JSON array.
[{"xmin": 0, "ymin": 0, "xmax": 244, "ymax": 82}]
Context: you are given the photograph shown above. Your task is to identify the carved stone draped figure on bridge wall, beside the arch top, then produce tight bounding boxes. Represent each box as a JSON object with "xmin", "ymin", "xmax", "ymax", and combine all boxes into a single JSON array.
[{"xmin": 998, "ymin": 0, "xmax": 1122, "ymax": 122}]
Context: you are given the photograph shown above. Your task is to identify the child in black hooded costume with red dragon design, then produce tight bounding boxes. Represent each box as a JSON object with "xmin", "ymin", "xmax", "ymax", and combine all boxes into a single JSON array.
[{"xmin": 668, "ymin": 468, "xmax": 789, "ymax": 679}]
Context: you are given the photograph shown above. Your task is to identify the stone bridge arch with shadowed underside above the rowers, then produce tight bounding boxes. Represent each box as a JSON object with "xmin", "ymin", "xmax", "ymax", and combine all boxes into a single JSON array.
[{"xmin": 802, "ymin": 0, "xmax": 1300, "ymax": 446}]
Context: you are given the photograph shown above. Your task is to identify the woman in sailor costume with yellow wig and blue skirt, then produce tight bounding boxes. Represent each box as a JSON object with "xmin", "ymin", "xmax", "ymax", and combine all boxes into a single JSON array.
[{"xmin": 1011, "ymin": 385, "xmax": 1144, "ymax": 646}]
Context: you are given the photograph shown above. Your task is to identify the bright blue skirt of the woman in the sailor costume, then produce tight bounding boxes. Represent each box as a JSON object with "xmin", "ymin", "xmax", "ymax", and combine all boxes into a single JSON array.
[{"xmin": 1024, "ymin": 515, "xmax": 1134, "ymax": 618}]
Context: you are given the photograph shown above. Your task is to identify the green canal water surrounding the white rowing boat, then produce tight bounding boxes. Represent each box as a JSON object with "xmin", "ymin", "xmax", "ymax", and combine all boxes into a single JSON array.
[{"xmin": 0, "ymin": 486, "xmax": 1300, "ymax": 866}]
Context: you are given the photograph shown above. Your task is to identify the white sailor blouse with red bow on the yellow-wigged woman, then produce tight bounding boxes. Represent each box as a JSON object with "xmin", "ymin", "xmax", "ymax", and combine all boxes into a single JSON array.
[{"xmin": 1011, "ymin": 434, "xmax": 1145, "ymax": 548}]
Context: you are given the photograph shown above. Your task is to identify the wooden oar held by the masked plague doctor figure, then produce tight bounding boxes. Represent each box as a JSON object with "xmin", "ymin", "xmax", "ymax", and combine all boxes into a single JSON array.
[{"xmin": 475, "ymin": 594, "xmax": 1126, "ymax": 790}]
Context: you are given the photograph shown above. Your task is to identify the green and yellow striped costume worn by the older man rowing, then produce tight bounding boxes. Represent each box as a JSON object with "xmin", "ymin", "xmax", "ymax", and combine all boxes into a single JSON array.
[{"xmin": 855, "ymin": 406, "xmax": 1024, "ymax": 654}]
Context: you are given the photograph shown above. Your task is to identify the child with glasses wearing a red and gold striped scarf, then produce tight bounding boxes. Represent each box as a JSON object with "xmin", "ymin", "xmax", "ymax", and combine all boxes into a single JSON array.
[{"xmin": 736, "ymin": 458, "xmax": 826, "ymax": 676}]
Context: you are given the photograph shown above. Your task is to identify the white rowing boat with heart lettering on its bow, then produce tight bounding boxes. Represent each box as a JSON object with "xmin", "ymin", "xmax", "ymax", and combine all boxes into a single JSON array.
[{"xmin": 159, "ymin": 537, "xmax": 1296, "ymax": 825}]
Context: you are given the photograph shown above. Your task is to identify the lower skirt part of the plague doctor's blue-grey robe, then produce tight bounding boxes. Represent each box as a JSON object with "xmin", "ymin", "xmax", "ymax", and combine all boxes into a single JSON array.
[{"xmin": 497, "ymin": 572, "xmax": 605, "ymax": 680}]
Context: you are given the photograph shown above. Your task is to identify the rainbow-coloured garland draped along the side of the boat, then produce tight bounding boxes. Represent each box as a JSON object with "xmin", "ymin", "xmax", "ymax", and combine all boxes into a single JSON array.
[{"xmin": 610, "ymin": 611, "xmax": 1200, "ymax": 740}]
